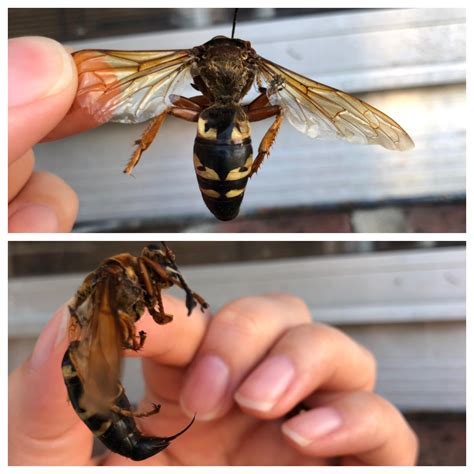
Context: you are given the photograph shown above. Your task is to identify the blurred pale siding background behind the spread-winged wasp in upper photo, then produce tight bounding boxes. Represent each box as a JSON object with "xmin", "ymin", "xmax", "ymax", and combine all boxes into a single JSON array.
[{"xmin": 9, "ymin": 8, "xmax": 466, "ymax": 232}]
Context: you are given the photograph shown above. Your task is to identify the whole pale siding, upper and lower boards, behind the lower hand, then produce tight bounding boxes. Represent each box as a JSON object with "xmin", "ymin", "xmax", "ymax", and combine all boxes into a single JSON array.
[{"xmin": 9, "ymin": 248, "xmax": 466, "ymax": 410}]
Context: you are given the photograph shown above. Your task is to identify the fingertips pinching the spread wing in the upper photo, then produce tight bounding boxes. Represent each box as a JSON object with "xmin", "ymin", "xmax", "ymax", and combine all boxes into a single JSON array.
[{"xmin": 8, "ymin": 37, "xmax": 78, "ymax": 232}]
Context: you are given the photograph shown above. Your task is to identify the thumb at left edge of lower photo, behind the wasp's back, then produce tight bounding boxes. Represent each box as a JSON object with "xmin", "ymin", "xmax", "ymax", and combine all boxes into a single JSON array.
[{"xmin": 8, "ymin": 306, "xmax": 92, "ymax": 466}]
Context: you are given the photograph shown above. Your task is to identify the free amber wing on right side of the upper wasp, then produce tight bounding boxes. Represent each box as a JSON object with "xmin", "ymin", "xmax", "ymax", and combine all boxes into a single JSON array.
[{"xmin": 259, "ymin": 58, "xmax": 414, "ymax": 150}]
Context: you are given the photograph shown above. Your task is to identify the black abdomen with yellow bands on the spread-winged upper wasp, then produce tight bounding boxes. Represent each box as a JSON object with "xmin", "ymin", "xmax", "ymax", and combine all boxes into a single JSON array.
[{"xmin": 194, "ymin": 106, "xmax": 253, "ymax": 221}]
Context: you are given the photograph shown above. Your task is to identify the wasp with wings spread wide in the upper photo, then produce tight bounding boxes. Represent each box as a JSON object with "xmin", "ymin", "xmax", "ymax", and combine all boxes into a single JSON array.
[{"xmin": 68, "ymin": 9, "xmax": 414, "ymax": 221}]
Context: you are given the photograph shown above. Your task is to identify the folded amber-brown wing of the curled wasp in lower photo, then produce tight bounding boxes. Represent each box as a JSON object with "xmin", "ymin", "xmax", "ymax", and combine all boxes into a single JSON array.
[{"xmin": 75, "ymin": 279, "xmax": 122, "ymax": 412}]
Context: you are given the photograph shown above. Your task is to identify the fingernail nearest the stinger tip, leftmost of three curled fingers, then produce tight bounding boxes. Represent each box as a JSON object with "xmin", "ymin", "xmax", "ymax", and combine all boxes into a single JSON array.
[{"xmin": 181, "ymin": 355, "xmax": 230, "ymax": 421}]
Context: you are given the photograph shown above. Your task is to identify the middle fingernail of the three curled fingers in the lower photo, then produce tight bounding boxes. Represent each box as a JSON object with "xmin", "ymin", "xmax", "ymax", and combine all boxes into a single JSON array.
[{"xmin": 234, "ymin": 355, "xmax": 295, "ymax": 412}]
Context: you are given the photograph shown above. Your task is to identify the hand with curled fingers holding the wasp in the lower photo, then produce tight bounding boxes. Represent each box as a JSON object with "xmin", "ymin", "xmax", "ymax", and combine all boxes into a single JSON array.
[{"xmin": 9, "ymin": 295, "xmax": 418, "ymax": 465}]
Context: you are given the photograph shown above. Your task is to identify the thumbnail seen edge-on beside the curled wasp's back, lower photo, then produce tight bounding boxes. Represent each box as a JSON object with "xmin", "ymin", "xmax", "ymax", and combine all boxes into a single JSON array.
[{"xmin": 29, "ymin": 304, "xmax": 69, "ymax": 371}]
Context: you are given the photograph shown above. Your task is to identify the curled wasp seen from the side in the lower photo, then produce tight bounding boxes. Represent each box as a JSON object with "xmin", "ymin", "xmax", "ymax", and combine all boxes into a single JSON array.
[{"xmin": 62, "ymin": 243, "xmax": 208, "ymax": 461}]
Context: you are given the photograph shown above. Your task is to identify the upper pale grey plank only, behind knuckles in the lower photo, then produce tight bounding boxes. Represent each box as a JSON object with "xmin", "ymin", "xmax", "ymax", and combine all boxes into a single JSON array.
[{"xmin": 9, "ymin": 248, "xmax": 466, "ymax": 336}]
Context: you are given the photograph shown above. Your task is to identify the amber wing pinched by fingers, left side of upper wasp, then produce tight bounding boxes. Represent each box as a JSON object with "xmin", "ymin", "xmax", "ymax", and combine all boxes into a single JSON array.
[{"xmin": 73, "ymin": 50, "xmax": 192, "ymax": 123}]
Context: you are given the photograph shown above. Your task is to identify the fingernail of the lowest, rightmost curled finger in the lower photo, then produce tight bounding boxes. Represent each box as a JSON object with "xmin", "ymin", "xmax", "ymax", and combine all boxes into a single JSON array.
[{"xmin": 282, "ymin": 408, "xmax": 342, "ymax": 446}]
